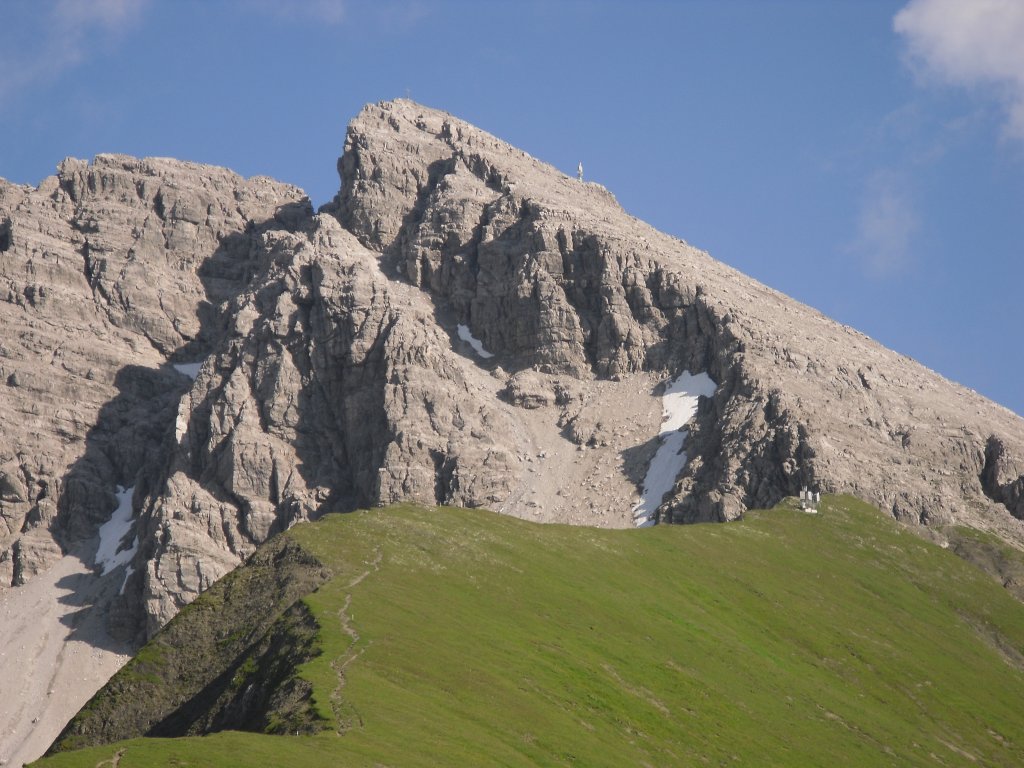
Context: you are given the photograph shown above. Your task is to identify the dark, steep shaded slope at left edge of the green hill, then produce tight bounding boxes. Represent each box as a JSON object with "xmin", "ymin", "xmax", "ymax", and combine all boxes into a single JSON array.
[{"xmin": 49, "ymin": 537, "xmax": 330, "ymax": 751}]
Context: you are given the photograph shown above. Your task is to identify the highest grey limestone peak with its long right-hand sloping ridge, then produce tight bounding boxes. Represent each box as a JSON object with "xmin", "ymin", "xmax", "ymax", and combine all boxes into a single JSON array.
[{"xmin": 337, "ymin": 101, "xmax": 1024, "ymax": 543}]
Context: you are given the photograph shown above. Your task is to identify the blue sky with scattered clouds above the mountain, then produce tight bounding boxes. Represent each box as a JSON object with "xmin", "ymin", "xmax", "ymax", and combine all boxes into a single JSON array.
[{"xmin": 0, "ymin": 0, "xmax": 1024, "ymax": 414}]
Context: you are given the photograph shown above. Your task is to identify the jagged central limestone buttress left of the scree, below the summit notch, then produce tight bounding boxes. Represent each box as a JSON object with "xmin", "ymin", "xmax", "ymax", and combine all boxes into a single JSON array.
[{"xmin": 131, "ymin": 214, "xmax": 516, "ymax": 632}]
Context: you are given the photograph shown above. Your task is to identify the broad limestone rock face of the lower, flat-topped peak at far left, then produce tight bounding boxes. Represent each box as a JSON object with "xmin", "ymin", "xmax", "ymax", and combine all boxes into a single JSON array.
[{"xmin": 0, "ymin": 156, "xmax": 308, "ymax": 585}]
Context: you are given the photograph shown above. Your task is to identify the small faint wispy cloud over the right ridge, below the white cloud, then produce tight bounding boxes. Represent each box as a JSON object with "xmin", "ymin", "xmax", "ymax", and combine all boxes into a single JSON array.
[{"xmin": 850, "ymin": 170, "xmax": 921, "ymax": 280}]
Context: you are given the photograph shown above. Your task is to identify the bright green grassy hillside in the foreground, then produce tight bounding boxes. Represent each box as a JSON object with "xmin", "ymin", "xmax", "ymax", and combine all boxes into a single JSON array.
[{"xmin": 38, "ymin": 498, "xmax": 1024, "ymax": 768}]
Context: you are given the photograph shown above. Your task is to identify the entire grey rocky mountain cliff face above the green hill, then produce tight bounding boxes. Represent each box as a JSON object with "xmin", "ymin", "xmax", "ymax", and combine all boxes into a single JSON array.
[{"xmin": 0, "ymin": 100, "xmax": 1024, "ymax": 634}]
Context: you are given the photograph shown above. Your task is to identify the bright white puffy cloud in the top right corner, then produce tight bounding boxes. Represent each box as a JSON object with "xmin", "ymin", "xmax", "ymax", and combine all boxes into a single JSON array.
[{"xmin": 893, "ymin": 0, "xmax": 1024, "ymax": 139}]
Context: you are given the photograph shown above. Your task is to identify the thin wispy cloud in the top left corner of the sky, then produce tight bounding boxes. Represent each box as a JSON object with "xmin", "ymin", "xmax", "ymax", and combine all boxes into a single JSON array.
[{"xmin": 0, "ymin": 0, "xmax": 148, "ymax": 97}]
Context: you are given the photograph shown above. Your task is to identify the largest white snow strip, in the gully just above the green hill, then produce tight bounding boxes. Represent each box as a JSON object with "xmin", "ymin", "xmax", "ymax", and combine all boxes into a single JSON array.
[{"xmin": 633, "ymin": 371, "xmax": 717, "ymax": 528}]
